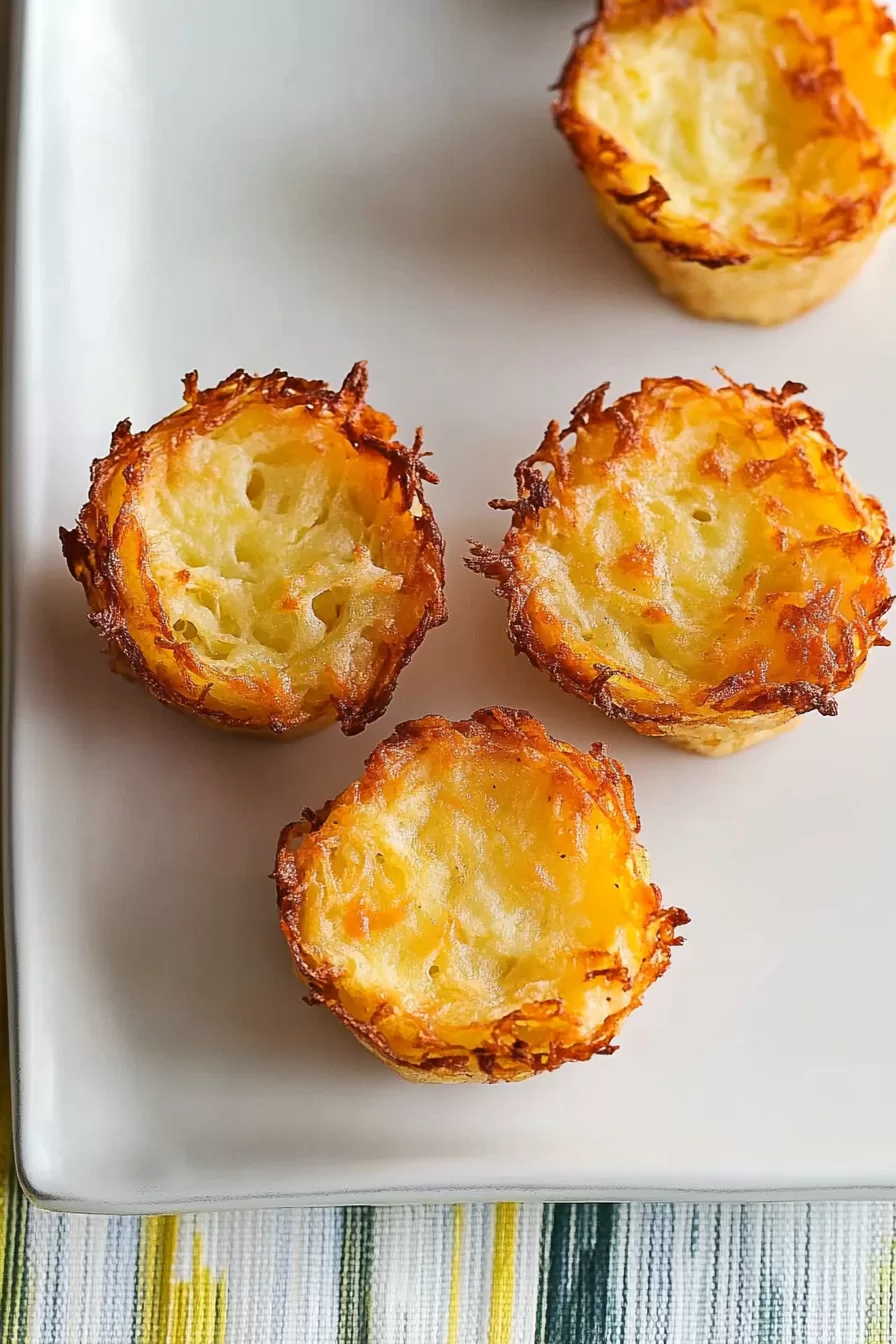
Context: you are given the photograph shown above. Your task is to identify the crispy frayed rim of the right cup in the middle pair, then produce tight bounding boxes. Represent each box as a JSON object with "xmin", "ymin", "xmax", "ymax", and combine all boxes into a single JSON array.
[{"xmin": 465, "ymin": 370, "xmax": 896, "ymax": 735}]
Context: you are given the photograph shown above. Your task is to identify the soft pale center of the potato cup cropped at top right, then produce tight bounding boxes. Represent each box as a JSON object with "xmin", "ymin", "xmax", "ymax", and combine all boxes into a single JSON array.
[{"xmin": 578, "ymin": 0, "xmax": 870, "ymax": 246}]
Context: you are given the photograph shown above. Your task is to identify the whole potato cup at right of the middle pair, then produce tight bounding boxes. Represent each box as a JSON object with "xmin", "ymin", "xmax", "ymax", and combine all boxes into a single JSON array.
[{"xmin": 466, "ymin": 371, "xmax": 893, "ymax": 755}]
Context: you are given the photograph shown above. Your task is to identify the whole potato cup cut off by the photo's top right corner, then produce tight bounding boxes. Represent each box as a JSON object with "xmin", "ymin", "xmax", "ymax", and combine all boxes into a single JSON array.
[{"xmin": 553, "ymin": 0, "xmax": 896, "ymax": 323}]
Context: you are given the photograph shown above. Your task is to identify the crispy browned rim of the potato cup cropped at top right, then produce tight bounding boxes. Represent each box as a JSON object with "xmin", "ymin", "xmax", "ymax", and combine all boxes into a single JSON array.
[{"xmin": 553, "ymin": 0, "xmax": 896, "ymax": 269}]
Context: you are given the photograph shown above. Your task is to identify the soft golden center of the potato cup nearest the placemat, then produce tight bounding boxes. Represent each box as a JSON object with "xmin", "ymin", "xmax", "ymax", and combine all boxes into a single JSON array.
[{"xmin": 302, "ymin": 742, "xmax": 645, "ymax": 1039}]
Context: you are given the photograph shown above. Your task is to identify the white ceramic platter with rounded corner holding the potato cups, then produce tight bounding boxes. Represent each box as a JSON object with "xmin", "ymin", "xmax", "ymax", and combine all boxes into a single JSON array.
[{"xmin": 4, "ymin": 0, "xmax": 896, "ymax": 1211}]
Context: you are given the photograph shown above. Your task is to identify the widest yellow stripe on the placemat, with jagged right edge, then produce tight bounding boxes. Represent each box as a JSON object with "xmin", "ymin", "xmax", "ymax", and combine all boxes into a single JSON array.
[{"xmin": 137, "ymin": 1214, "xmax": 227, "ymax": 1344}]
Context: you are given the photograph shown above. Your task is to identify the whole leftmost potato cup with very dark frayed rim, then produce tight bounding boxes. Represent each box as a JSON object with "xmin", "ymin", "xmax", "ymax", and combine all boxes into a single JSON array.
[{"xmin": 59, "ymin": 363, "xmax": 446, "ymax": 737}]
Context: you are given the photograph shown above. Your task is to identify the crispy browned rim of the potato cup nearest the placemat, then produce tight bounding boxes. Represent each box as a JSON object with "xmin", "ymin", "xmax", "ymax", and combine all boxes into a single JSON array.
[{"xmin": 274, "ymin": 707, "xmax": 689, "ymax": 1082}]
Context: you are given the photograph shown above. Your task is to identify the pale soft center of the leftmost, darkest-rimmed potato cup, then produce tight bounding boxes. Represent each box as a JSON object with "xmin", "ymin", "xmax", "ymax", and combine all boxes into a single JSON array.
[{"xmin": 137, "ymin": 409, "xmax": 412, "ymax": 691}]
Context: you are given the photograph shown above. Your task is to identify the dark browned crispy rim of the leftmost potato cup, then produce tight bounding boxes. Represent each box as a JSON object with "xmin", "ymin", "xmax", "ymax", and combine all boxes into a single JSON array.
[{"xmin": 59, "ymin": 362, "xmax": 447, "ymax": 734}]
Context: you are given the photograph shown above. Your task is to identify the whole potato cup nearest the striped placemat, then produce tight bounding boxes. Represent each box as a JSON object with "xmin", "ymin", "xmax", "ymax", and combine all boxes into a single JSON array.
[{"xmin": 274, "ymin": 708, "xmax": 686, "ymax": 1082}]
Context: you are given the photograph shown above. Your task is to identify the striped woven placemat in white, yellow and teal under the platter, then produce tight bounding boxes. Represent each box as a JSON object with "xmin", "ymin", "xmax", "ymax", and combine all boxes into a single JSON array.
[{"xmin": 0, "ymin": 1124, "xmax": 896, "ymax": 1344}]
